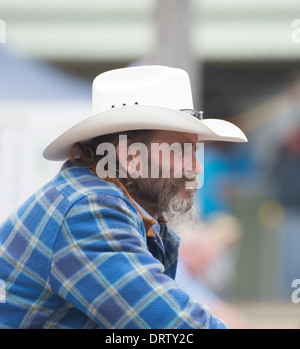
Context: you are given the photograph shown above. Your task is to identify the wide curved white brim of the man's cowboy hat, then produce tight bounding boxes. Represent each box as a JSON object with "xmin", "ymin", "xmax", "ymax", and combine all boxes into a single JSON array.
[{"xmin": 43, "ymin": 105, "xmax": 247, "ymax": 161}]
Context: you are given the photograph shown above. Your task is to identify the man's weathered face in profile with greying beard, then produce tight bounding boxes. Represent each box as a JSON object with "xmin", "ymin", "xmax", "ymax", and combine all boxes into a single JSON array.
[{"xmin": 129, "ymin": 131, "xmax": 203, "ymax": 215}]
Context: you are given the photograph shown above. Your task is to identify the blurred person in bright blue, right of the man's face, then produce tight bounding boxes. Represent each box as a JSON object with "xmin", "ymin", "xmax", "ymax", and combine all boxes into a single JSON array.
[{"xmin": 195, "ymin": 137, "xmax": 257, "ymax": 221}]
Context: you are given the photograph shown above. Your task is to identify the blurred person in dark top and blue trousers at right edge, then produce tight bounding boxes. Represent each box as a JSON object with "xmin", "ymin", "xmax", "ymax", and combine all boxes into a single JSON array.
[{"xmin": 272, "ymin": 126, "xmax": 300, "ymax": 299}]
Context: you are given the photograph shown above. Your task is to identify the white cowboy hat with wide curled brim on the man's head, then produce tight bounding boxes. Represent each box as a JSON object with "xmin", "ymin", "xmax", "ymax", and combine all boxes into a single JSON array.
[{"xmin": 43, "ymin": 65, "xmax": 247, "ymax": 160}]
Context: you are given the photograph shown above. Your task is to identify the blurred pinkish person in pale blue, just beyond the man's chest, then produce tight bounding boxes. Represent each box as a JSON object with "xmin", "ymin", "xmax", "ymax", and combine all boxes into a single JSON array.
[{"xmin": 176, "ymin": 213, "xmax": 250, "ymax": 329}]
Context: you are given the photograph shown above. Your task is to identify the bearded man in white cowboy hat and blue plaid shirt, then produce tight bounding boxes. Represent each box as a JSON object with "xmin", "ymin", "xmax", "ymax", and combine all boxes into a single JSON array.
[{"xmin": 0, "ymin": 66, "xmax": 246, "ymax": 329}]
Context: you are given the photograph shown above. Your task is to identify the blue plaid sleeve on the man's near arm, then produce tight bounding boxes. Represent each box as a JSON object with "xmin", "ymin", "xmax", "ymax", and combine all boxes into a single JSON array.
[{"xmin": 50, "ymin": 194, "xmax": 227, "ymax": 329}]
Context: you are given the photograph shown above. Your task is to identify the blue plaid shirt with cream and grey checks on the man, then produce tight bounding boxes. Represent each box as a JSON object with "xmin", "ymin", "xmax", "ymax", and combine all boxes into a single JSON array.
[{"xmin": 0, "ymin": 161, "xmax": 226, "ymax": 329}]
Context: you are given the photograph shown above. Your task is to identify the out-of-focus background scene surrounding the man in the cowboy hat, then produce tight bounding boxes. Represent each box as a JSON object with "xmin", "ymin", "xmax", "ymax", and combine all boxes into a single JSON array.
[{"xmin": 0, "ymin": 0, "xmax": 300, "ymax": 328}]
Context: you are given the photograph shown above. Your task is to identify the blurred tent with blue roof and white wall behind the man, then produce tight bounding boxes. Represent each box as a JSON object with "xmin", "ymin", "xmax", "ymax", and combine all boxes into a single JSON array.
[{"xmin": 0, "ymin": 45, "xmax": 91, "ymax": 222}]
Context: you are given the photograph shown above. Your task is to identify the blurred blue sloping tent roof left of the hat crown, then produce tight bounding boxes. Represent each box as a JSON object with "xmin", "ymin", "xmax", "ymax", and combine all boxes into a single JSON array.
[{"xmin": 0, "ymin": 44, "xmax": 91, "ymax": 100}]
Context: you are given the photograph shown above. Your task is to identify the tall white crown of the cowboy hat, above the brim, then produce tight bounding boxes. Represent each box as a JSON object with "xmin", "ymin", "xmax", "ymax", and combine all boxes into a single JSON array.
[{"xmin": 93, "ymin": 66, "xmax": 193, "ymax": 114}]
